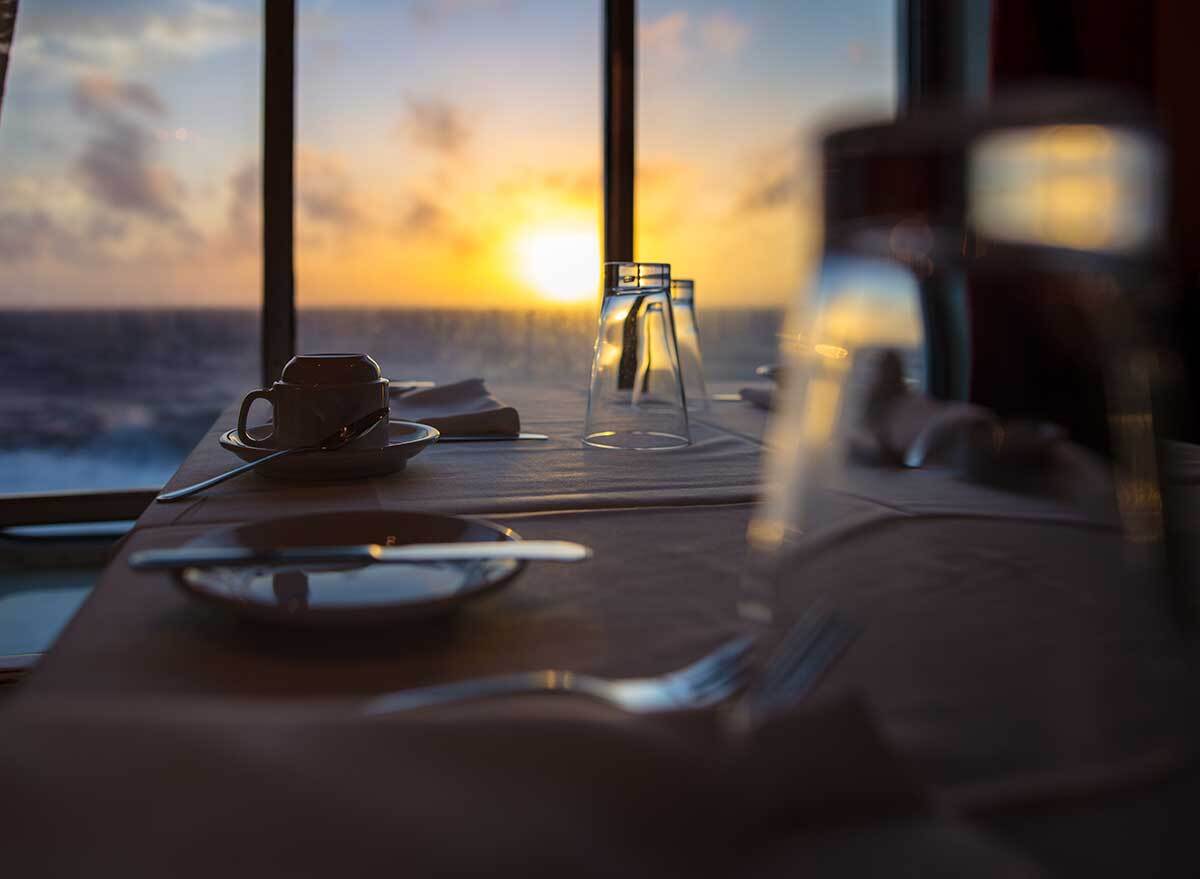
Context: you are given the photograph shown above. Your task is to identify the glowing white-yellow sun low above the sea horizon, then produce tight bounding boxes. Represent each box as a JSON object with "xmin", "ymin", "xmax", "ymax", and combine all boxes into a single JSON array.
[{"xmin": 516, "ymin": 226, "xmax": 600, "ymax": 303}]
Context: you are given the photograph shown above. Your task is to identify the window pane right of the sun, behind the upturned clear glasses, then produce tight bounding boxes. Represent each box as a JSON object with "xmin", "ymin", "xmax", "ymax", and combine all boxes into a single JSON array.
[{"xmin": 635, "ymin": 0, "xmax": 896, "ymax": 379}]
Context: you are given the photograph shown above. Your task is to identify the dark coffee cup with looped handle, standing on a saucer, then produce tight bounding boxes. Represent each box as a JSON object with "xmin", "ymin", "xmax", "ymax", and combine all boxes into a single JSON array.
[{"xmin": 238, "ymin": 354, "xmax": 388, "ymax": 449}]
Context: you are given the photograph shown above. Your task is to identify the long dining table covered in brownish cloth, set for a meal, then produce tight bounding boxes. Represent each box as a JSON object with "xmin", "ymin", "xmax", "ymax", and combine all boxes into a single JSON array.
[{"xmin": 0, "ymin": 383, "xmax": 1200, "ymax": 875}]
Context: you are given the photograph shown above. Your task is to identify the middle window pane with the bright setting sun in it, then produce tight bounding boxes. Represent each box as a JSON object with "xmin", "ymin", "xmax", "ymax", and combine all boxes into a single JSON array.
[{"xmin": 296, "ymin": 0, "xmax": 601, "ymax": 387}]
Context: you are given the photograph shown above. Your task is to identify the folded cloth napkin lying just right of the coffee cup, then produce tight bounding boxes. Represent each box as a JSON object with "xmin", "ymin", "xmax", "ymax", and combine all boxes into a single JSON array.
[{"xmin": 389, "ymin": 378, "xmax": 521, "ymax": 436}]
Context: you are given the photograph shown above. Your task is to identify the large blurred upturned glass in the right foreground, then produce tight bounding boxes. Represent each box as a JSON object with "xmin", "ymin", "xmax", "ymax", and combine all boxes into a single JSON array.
[{"xmin": 739, "ymin": 95, "xmax": 1178, "ymax": 641}]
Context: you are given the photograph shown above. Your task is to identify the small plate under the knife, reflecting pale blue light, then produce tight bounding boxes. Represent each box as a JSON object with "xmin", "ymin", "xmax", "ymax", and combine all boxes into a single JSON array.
[{"xmin": 175, "ymin": 510, "xmax": 524, "ymax": 627}]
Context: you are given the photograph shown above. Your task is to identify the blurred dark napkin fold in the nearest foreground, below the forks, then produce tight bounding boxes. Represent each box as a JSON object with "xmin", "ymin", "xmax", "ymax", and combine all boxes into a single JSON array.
[{"xmin": 0, "ymin": 695, "xmax": 1040, "ymax": 879}]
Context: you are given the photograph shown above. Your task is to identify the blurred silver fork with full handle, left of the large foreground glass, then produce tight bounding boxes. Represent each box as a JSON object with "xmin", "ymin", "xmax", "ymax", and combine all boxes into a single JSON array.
[{"xmin": 364, "ymin": 635, "xmax": 754, "ymax": 716}]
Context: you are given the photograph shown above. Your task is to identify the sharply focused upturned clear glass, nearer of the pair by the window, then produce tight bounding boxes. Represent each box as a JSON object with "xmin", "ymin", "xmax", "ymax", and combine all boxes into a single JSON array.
[{"xmin": 583, "ymin": 263, "xmax": 691, "ymax": 450}]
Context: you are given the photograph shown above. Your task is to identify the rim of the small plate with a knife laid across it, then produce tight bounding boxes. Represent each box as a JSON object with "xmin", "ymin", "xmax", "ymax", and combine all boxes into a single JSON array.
[{"xmin": 170, "ymin": 509, "xmax": 528, "ymax": 629}]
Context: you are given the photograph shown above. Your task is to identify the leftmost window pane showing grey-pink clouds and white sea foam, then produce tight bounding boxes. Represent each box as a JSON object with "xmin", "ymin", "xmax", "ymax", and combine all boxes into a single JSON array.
[{"xmin": 0, "ymin": 0, "xmax": 262, "ymax": 492}]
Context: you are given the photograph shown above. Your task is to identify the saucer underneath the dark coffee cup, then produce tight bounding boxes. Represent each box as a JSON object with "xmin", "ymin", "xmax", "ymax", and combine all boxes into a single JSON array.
[{"xmin": 221, "ymin": 421, "xmax": 440, "ymax": 480}]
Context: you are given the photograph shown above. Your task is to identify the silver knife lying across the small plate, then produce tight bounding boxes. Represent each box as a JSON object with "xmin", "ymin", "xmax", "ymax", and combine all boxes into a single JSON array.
[{"xmin": 130, "ymin": 540, "xmax": 592, "ymax": 570}]
